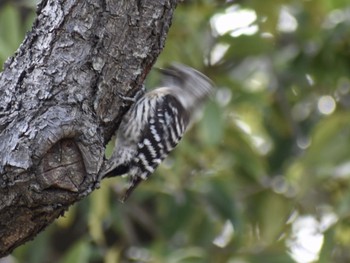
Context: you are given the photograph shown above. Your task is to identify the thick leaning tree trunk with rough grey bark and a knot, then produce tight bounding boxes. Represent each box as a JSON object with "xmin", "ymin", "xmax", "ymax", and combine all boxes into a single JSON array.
[{"xmin": 0, "ymin": 0, "xmax": 177, "ymax": 257}]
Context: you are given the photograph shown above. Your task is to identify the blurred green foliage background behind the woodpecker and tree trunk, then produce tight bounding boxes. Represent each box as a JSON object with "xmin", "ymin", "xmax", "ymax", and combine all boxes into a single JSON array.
[{"xmin": 0, "ymin": 0, "xmax": 350, "ymax": 263}]
